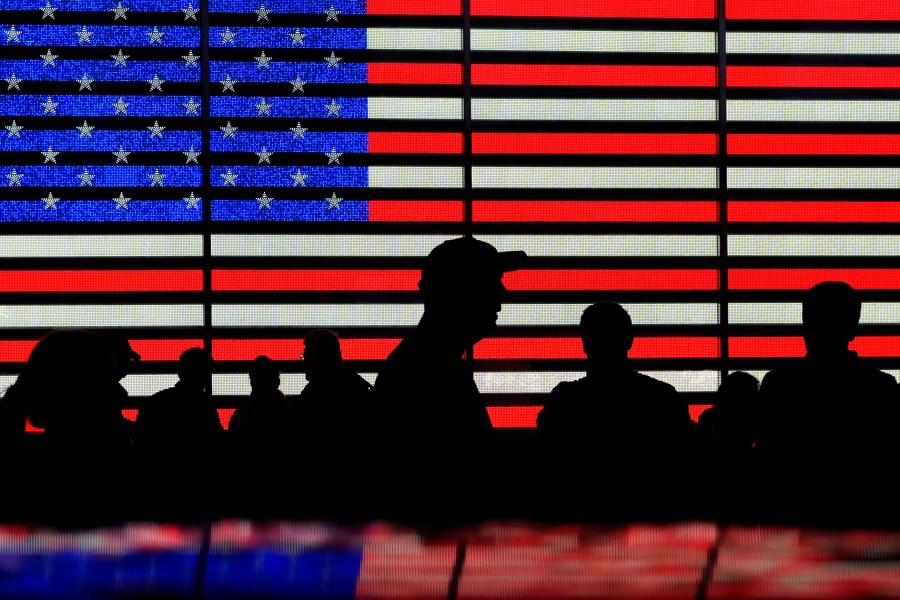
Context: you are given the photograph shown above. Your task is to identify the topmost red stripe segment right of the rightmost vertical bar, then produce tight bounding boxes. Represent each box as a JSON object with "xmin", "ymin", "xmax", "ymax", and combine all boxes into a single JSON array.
[{"xmin": 725, "ymin": 0, "xmax": 900, "ymax": 21}]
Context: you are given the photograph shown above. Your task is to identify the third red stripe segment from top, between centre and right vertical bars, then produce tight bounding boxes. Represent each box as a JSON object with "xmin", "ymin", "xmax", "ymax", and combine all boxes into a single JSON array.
[{"xmin": 472, "ymin": 133, "xmax": 719, "ymax": 154}]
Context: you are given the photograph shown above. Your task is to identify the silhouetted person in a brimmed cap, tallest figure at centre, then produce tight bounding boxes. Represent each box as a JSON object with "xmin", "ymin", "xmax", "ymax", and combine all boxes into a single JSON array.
[{"xmin": 375, "ymin": 237, "xmax": 525, "ymax": 519}]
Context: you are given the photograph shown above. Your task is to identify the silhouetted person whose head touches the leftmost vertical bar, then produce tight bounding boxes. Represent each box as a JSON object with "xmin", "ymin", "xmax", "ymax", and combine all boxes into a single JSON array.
[{"xmin": 137, "ymin": 348, "xmax": 224, "ymax": 519}]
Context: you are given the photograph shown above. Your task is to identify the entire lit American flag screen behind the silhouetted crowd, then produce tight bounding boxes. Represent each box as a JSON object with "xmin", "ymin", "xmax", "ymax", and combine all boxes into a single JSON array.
[{"xmin": 0, "ymin": 0, "xmax": 900, "ymax": 427}]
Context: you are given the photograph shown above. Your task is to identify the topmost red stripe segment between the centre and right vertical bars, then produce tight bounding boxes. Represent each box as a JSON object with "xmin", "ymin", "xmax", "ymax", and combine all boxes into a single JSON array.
[{"xmin": 468, "ymin": 0, "xmax": 716, "ymax": 19}]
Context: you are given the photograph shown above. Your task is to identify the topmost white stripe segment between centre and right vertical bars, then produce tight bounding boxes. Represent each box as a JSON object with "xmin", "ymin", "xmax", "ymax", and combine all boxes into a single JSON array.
[{"xmin": 472, "ymin": 29, "xmax": 716, "ymax": 53}]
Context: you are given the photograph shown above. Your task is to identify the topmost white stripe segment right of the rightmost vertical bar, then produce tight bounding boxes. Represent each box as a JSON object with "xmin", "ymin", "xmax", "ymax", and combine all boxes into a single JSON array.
[{"xmin": 725, "ymin": 31, "xmax": 900, "ymax": 54}]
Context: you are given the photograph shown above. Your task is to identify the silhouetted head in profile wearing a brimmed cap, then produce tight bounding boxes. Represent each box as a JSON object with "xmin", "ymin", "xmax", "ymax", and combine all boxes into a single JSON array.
[{"xmin": 419, "ymin": 237, "xmax": 526, "ymax": 344}]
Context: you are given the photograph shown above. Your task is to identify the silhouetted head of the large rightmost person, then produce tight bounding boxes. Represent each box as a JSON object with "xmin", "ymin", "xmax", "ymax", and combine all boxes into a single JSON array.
[{"xmin": 803, "ymin": 281, "xmax": 862, "ymax": 355}]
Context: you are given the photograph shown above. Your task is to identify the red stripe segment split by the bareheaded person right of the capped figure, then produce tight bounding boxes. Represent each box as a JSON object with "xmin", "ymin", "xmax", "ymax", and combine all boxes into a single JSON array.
[{"xmin": 474, "ymin": 337, "xmax": 719, "ymax": 360}]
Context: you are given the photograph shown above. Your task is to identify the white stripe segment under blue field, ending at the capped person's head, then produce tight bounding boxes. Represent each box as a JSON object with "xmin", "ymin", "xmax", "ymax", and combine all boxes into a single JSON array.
[{"xmin": 212, "ymin": 234, "xmax": 457, "ymax": 257}]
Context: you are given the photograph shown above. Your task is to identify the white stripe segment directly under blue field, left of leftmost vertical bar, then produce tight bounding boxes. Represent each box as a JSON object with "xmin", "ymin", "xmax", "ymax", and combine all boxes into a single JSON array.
[{"xmin": 0, "ymin": 235, "xmax": 203, "ymax": 258}]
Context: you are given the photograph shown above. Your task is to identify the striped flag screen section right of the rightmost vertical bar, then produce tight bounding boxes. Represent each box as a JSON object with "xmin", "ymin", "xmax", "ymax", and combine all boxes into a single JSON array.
[{"xmin": 726, "ymin": 0, "xmax": 900, "ymax": 375}]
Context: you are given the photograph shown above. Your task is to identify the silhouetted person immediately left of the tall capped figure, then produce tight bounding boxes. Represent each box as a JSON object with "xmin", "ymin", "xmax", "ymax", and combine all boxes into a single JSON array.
[{"xmin": 292, "ymin": 329, "xmax": 374, "ymax": 518}]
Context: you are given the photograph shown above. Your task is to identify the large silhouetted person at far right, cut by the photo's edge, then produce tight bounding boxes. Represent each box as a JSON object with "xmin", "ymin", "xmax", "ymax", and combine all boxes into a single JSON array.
[{"xmin": 756, "ymin": 281, "xmax": 898, "ymax": 522}]
